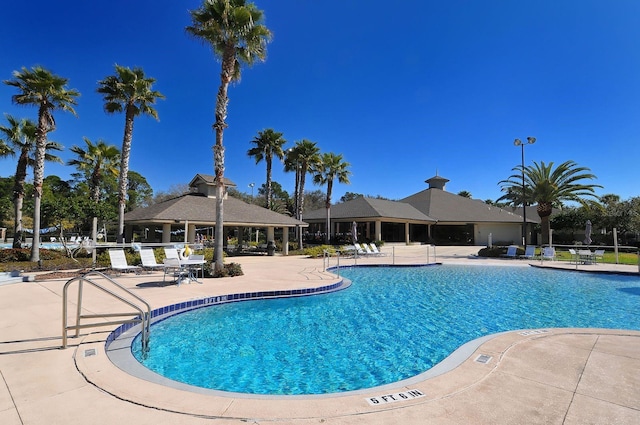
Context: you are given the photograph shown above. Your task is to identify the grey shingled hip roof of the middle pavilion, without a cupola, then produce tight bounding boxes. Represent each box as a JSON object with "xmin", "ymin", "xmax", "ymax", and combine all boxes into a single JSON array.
[{"xmin": 304, "ymin": 196, "xmax": 436, "ymax": 223}]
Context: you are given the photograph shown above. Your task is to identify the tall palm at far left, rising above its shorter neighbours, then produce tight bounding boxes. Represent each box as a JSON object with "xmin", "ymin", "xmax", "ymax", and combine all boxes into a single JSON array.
[{"xmin": 4, "ymin": 66, "xmax": 80, "ymax": 262}]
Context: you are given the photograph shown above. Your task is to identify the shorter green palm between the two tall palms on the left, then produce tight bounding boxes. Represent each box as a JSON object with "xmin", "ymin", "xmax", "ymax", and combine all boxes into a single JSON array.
[{"xmin": 67, "ymin": 137, "xmax": 120, "ymax": 203}]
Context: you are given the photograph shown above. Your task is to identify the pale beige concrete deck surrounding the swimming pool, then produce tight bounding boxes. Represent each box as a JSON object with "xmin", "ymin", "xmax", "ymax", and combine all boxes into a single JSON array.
[{"xmin": 0, "ymin": 247, "xmax": 640, "ymax": 425}]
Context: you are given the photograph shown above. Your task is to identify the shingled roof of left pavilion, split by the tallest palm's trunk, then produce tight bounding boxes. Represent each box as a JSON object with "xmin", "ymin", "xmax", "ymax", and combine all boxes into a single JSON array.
[{"xmin": 124, "ymin": 193, "xmax": 308, "ymax": 227}]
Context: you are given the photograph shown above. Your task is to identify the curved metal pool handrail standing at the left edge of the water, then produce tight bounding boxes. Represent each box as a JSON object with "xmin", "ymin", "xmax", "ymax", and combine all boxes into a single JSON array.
[{"xmin": 62, "ymin": 270, "xmax": 151, "ymax": 352}]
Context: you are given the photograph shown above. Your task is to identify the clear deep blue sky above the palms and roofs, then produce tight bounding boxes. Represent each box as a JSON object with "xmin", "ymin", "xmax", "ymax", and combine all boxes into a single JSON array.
[{"xmin": 0, "ymin": 0, "xmax": 640, "ymax": 201}]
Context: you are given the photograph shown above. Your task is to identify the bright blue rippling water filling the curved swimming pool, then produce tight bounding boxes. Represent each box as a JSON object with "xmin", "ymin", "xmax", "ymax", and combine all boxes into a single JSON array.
[{"xmin": 134, "ymin": 266, "xmax": 640, "ymax": 394}]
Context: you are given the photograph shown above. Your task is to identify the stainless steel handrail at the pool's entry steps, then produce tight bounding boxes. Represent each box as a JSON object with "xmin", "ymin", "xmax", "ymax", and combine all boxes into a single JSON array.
[{"xmin": 62, "ymin": 271, "xmax": 151, "ymax": 351}]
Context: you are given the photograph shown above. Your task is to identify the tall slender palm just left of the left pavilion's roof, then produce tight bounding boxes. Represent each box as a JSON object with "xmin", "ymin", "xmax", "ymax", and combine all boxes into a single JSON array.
[{"xmin": 98, "ymin": 65, "xmax": 164, "ymax": 243}]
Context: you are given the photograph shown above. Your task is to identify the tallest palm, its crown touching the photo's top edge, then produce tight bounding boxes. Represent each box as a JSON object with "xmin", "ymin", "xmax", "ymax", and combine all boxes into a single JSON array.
[{"xmin": 186, "ymin": 0, "xmax": 271, "ymax": 272}]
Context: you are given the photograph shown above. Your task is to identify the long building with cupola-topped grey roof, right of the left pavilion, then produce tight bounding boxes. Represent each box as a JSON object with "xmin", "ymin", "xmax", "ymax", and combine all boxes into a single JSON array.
[{"xmin": 305, "ymin": 175, "xmax": 536, "ymax": 245}]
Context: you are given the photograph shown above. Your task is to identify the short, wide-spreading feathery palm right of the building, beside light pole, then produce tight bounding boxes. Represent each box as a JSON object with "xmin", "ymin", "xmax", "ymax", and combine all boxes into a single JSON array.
[{"xmin": 496, "ymin": 161, "xmax": 602, "ymax": 244}]
